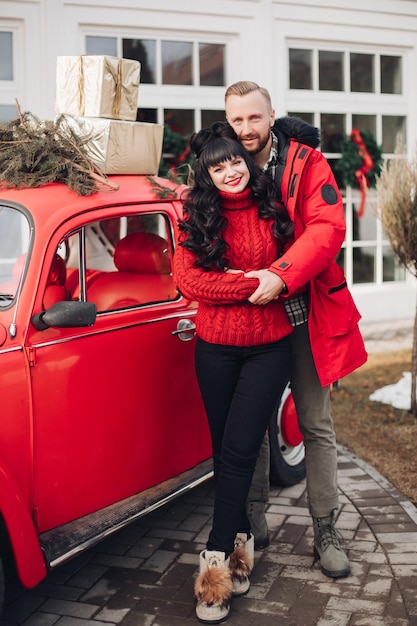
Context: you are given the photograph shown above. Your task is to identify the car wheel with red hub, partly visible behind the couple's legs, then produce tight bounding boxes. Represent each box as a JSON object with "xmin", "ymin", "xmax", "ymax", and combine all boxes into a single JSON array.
[{"xmin": 269, "ymin": 383, "xmax": 306, "ymax": 487}]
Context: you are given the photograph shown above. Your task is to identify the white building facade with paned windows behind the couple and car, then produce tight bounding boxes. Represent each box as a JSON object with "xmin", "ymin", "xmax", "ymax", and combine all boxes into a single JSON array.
[{"xmin": 0, "ymin": 0, "xmax": 417, "ymax": 321}]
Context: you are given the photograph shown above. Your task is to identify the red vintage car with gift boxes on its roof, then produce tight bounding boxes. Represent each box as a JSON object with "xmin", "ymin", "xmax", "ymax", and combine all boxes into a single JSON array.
[{"xmin": 0, "ymin": 176, "xmax": 304, "ymax": 610}]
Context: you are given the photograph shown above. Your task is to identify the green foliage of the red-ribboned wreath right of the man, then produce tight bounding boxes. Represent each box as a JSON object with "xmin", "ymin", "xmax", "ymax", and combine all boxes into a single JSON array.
[{"xmin": 335, "ymin": 131, "xmax": 383, "ymax": 189}]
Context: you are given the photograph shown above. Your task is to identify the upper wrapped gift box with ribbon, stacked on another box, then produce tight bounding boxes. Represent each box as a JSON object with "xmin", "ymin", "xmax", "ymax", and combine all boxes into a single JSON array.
[{"xmin": 55, "ymin": 55, "xmax": 141, "ymax": 121}]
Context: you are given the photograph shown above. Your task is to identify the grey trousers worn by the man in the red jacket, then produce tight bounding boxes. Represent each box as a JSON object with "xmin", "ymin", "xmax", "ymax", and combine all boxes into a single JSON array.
[{"xmin": 247, "ymin": 323, "xmax": 339, "ymax": 520}]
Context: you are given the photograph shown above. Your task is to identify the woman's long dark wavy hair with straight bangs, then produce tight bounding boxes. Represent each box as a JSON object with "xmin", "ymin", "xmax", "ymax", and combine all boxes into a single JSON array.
[{"xmin": 179, "ymin": 122, "xmax": 294, "ymax": 270}]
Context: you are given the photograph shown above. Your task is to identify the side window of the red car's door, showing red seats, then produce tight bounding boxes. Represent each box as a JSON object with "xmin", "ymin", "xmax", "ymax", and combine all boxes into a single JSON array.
[{"xmin": 60, "ymin": 213, "xmax": 178, "ymax": 313}]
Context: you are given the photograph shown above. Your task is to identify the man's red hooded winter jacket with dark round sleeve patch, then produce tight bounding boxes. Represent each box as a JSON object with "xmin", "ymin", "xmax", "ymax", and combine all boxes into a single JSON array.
[{"xmin": 269, "ymin": 118, "xmax": 367, "ymax": 386}]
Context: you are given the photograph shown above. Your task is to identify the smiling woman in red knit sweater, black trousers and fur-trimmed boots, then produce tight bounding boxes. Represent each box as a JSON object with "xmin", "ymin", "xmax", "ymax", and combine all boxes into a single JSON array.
[{"xmin": 174, "ymin": 125, "xmax": 293, "ymax": 623}]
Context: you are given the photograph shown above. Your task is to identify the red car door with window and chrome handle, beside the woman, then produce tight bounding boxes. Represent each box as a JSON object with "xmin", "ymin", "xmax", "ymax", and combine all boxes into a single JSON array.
[{"xmin": 29, "ymin": 203, "xmax": 211, "ymax": 531}]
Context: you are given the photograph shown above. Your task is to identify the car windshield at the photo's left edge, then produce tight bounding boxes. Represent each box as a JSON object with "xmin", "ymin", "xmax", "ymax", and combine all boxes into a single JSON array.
[{"xmin": 0, "ymin": 205, "xmax": 30, "ymax": 308}]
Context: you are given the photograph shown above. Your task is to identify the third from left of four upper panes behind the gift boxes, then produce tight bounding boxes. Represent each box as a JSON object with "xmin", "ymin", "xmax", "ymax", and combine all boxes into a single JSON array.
[{"xmin": 161, "ymin": 41, "xmax": 193, "ymax": 85}]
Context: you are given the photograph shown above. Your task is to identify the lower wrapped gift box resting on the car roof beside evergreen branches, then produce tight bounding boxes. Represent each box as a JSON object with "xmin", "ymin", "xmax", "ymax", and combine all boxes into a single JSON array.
[{"xmin": 65, "ymin": 116, "xmax": 164, "ymax": 175}]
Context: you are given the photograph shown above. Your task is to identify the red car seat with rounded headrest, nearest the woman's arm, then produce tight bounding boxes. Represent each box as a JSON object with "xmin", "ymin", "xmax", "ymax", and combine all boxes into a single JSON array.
[{"xmin": 87, "ymin": 232, "xmax": 177, "ymax": 311}]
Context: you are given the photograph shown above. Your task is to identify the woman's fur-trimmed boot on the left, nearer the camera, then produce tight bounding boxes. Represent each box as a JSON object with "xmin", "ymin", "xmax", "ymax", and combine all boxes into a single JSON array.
[{"xmin": 194, "ymin": 550, "xmax": 233, "ymax": 624}]
